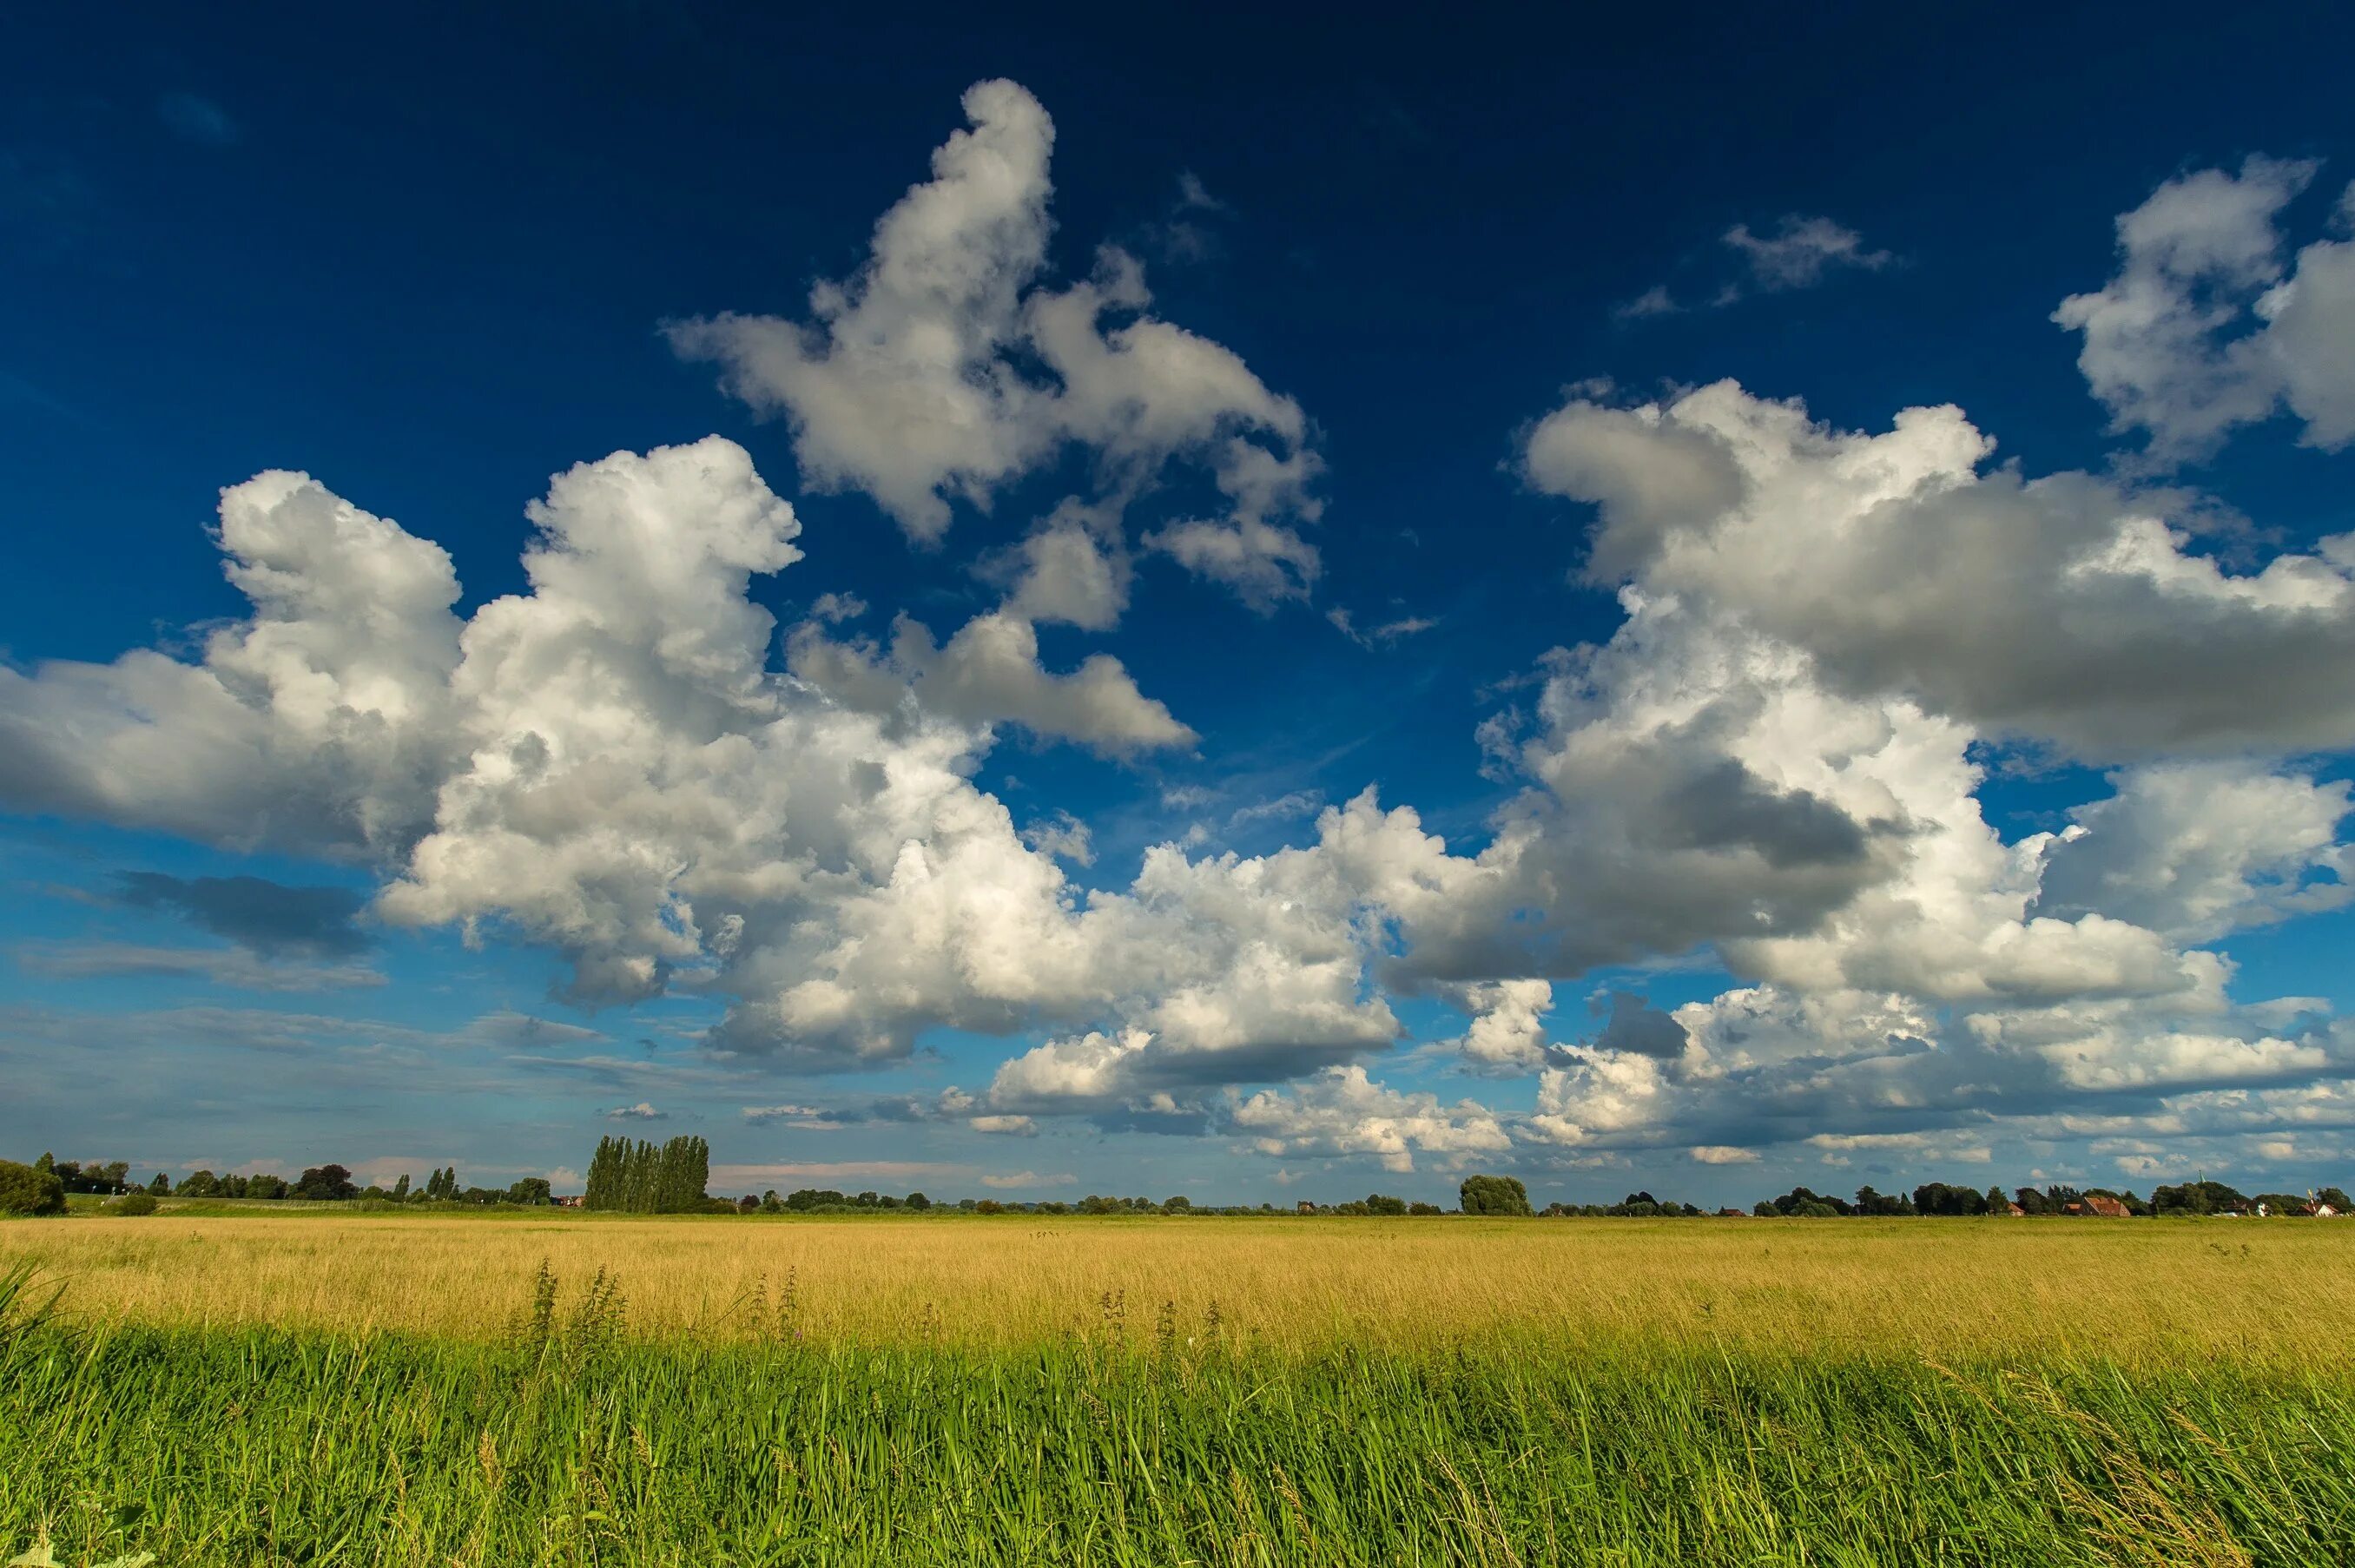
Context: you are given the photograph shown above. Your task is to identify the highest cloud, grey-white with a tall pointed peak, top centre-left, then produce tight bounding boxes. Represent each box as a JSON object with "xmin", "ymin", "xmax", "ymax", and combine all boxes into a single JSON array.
[{"xmin": 669, "ymin": 82, "xmax": 1314, "ymax": 591}]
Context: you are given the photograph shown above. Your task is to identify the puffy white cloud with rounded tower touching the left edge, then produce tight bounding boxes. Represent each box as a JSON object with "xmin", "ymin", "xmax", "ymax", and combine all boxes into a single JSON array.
[{"xmin": 0, "ymin": 471, "xmax": 459, "ymax": 857}]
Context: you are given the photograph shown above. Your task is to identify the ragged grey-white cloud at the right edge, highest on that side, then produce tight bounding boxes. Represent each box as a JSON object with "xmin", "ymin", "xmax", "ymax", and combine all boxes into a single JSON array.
[{"xmin": 2054, "ymin": 158, "xmax": 2355, "ymax": 464}]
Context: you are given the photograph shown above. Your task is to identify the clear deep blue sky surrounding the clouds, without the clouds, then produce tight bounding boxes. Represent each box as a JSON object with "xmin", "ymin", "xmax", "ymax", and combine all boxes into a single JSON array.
[{"xmin": 0, "ymin": 3, "xmax": 2355, "ymax": 1196}]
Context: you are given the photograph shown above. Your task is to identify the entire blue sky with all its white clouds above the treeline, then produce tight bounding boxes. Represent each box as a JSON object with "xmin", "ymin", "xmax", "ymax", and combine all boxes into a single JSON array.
[{"xmin": 0, "ymin": 7, "xmax": 2355, "ymax": 1203}]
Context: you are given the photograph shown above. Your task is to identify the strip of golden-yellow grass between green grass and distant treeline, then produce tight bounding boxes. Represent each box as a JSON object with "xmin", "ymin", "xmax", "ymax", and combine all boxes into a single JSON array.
[{"xmin": 0, "ymin": 1215, "xmax": 2355, "ymax": 1363}]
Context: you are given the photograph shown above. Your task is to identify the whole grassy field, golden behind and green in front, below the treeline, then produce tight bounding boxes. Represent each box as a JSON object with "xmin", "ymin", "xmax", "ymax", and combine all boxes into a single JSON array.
[{"xmin": 0, "ymin": 1215, "xmax": 2355, "ymax": 1568}]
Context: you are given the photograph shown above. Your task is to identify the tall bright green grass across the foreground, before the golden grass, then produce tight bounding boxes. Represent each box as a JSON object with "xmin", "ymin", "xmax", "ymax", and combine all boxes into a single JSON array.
[{"xmin": 0, "ymin": 1271, "xmax": 2355, "ymax": 1568}]
